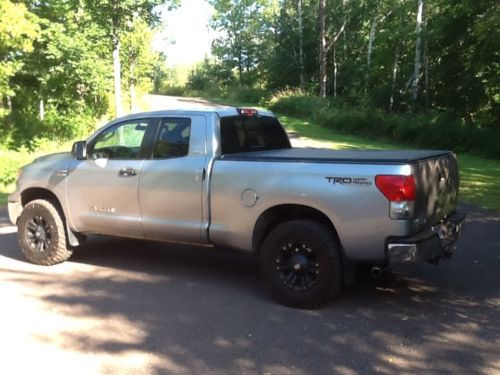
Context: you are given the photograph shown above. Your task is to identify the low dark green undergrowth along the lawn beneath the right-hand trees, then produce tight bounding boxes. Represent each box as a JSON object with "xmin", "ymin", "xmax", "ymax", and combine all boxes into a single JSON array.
[{"xmin": 269, "ymin": 89, "xmax": 500, "ymax": 158}]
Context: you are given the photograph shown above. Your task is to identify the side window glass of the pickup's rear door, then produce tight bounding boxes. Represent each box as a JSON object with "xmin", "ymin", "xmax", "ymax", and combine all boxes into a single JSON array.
[{"xmin": 153, "ymin": 118, "xmax": 191, "ymax": 159}]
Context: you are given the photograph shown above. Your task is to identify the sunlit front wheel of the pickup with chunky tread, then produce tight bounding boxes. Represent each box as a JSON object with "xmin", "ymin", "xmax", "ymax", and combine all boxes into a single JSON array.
[{"xmin": 17, "ymin": 199, "xmax": 73, "ymax": 266}]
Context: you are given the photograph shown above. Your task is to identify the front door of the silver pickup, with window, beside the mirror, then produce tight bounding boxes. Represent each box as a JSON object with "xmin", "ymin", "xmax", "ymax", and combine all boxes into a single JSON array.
[{"xmin": 67, "ymin": 119, "xmax": 155, "ymax": 237}]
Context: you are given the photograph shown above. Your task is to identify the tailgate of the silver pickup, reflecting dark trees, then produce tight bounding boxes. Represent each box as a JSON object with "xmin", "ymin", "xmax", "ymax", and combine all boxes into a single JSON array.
[{"xmin": 412, "ymin": 152, "xmax": 459, "ymax": 229}]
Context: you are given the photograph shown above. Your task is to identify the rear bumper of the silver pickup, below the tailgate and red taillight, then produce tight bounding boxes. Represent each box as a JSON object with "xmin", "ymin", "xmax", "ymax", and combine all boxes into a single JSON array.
[{"xmin": 386, "ymin": 213, "xmax": 465, "ymax": 264}]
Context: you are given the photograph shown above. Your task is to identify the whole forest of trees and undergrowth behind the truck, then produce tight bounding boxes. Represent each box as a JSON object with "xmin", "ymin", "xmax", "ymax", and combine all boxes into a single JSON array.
[{"xmin": 0, "ymin": 0, "xmax": 500, "ymax": 203}]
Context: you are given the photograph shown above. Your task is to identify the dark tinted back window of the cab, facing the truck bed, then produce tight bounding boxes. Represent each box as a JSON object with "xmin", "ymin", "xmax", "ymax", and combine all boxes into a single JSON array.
[{"xmin": 220, "ymin": 116, "xmax": 291, "ymax": 155}]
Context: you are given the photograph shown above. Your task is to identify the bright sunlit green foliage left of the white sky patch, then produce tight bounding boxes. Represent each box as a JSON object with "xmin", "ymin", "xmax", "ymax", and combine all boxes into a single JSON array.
[{"xmin": 0, "ymin": 0, "xmax": 169, "ymax": 149}]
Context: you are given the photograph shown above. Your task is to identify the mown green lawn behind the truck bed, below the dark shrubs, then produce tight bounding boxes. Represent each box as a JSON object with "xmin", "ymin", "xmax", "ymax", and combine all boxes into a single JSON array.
[{"xmin": 279, "ymin": 115, "xmax": 500, "ymax": 211}]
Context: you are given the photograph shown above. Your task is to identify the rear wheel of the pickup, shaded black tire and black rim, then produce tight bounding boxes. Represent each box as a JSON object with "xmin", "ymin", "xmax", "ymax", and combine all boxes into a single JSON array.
[{"xmin": 259, "ymin": 220, "xmax": 343, "ymax": 309}]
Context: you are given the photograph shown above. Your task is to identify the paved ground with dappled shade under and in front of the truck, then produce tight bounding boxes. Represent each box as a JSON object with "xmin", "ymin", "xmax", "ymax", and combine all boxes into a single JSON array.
[{"xmin": 0, "ymin": 206, "xmax": 500, "ymax": 374}]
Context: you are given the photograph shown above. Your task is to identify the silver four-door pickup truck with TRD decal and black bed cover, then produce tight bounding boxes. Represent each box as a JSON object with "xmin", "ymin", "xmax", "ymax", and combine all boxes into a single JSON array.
[{"xmin": 8, "ymin": 108, "xmax": 464, "ymax": 308}]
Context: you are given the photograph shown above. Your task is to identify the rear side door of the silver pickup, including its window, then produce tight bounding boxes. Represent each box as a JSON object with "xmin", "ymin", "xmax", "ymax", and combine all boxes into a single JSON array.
[{"xmin": 139, "ymin": 115, "xmax": 208, "ymax": 243}]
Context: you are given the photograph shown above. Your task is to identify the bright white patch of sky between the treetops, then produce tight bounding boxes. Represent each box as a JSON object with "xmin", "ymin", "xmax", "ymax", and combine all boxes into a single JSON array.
[{"xmin": 153, "ymin": 0, "xmax": 214, "ymax": 66}]
